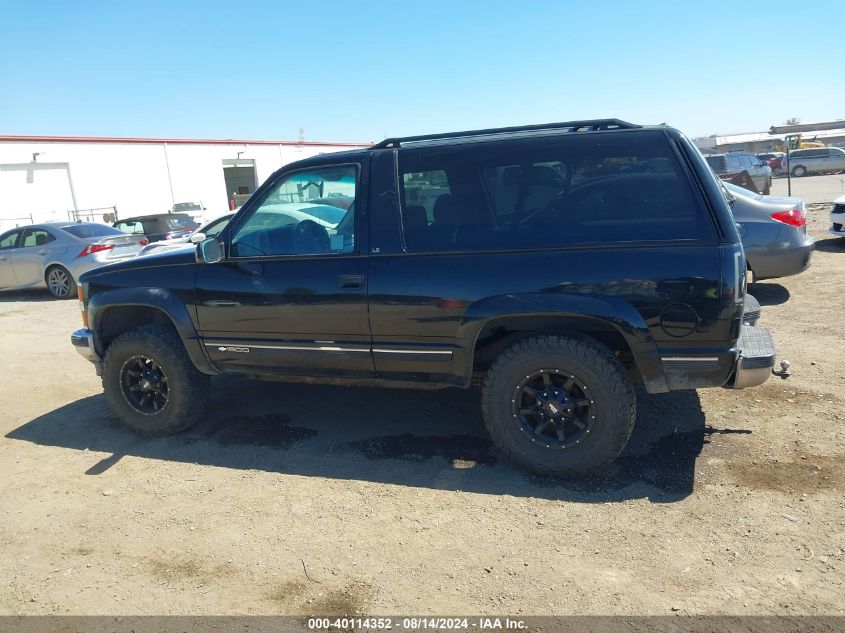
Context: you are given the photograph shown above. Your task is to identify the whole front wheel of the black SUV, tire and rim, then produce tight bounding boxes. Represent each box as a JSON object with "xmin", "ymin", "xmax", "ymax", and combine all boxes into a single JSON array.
[{"xmin": 103, "ymin": 325, "xmax": 210, "ymax": 436}]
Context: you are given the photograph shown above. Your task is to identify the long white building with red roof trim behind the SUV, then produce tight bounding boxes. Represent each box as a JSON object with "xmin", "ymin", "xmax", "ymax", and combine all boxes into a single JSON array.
[{"xmin": 0, "ymin": 135, "xmax": 368, "ymax": 231}]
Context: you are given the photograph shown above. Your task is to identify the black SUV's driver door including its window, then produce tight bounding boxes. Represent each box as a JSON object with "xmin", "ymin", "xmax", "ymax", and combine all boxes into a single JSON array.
[{"xmin": 196, "ymin": 163, "xmax": 375, "ymax": 377}]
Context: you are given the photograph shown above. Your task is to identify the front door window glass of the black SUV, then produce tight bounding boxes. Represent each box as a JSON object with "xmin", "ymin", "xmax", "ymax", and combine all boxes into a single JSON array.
[{"xmin": 231, "ymin": 165, "xmax": 358, "ymax": 257}]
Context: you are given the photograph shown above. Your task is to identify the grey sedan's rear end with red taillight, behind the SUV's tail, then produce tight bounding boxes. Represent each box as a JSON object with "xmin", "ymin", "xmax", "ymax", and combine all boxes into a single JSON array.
[{"xmin": 723, "ymin": 182, "xmax": 814, "ymax": 281}]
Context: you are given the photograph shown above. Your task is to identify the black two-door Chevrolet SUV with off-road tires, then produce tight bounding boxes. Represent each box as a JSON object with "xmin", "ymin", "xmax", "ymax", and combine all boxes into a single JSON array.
[{"xmin": 67, "ymin": 119, "xmax": 775, "ymax": 475}]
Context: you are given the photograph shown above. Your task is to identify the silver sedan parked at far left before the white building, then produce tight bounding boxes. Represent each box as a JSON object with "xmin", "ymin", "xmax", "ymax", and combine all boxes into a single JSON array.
[{"xmin": 0, "ymin": 222, "xmax": 149, "ymax": 299}]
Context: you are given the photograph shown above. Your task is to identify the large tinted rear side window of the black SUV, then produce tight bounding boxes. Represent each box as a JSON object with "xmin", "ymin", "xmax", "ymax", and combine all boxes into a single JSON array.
[{"xmin": 399, "ymin": 131, "xmax": 715, "ymax": 252}]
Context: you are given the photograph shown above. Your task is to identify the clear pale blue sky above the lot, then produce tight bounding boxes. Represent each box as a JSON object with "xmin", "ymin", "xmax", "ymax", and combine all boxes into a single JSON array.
[{"xmin": 0, "ymin": 0, "xmax": 845, "ymax": 141}]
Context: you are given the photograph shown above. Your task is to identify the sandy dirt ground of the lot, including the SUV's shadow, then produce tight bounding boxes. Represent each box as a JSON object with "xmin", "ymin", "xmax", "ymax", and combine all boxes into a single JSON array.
[{"xmin": 0, "ymin": 207, "xmax": 845, "ymax": 615}]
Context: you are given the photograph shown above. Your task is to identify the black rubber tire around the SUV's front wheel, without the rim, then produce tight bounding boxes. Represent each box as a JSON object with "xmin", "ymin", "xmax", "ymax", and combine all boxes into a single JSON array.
[{"xmin": 103, "ymin": 325, "xmax": 210, "ymax": 437}]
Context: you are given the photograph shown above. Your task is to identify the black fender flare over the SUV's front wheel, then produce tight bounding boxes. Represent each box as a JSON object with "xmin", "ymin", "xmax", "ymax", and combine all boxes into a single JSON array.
[{"xmin": 88, "ymin": 287, "xmax": 219, "ymax": 374}]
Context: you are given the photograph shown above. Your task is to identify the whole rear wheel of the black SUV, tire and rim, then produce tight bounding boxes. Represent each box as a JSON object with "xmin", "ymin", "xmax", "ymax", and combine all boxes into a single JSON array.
[{"xmin": 482, "ymin": 334, "xmax": 636, "ymax": 476}]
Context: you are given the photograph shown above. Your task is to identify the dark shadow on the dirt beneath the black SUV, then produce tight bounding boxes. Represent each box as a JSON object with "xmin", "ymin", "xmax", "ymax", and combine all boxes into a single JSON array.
[{"xmin": 6, "ymin": 378, "xmax": 728, "ymax": 503}]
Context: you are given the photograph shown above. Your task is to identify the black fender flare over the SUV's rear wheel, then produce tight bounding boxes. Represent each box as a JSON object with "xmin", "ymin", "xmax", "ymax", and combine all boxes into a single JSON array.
[{"xmin": 456, "ymin": 293, "xmax": 669, "ymax": 393}]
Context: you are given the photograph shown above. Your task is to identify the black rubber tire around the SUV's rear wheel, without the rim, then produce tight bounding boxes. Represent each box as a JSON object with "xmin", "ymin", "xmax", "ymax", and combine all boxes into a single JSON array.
[{"xmin": 481, "ymin": 334, "xmax": 636, "ymax": 477}]
